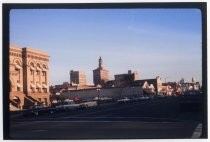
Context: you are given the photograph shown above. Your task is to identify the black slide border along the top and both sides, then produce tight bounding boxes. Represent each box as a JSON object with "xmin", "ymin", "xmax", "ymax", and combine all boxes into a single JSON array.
[{"xmin": 2, "ymin": 2, "xmax": 208, "ymax": 140}]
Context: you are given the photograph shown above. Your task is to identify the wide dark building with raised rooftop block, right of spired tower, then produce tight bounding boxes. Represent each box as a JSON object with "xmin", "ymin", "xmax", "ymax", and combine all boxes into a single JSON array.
[{"xmin": 114, "ymin": 70, "xmax": 139, "ymax": 87}]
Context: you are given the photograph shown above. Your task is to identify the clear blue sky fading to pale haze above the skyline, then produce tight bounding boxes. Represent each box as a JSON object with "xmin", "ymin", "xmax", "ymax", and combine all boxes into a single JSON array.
[{"xmin": 9, "ymin": 9, "xmax": 202, "ymax": 85}]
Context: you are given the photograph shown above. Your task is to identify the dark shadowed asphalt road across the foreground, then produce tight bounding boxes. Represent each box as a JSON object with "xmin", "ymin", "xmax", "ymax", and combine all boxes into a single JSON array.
[{"xmin": 9, "ymin": 98, "xmax": 202, "ymax": 139}]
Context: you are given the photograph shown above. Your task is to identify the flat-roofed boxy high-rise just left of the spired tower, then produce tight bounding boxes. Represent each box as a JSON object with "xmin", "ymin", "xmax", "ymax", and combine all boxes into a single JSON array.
[{"xmin": 70, "ymin": 70, "xmax": 86, "ymax": 85}]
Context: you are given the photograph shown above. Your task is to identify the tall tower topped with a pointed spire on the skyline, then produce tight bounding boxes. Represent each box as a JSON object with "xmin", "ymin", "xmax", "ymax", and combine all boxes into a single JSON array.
[{"xmin": 93, "ymin": 57, "xmax": 109, "ymax": 86}]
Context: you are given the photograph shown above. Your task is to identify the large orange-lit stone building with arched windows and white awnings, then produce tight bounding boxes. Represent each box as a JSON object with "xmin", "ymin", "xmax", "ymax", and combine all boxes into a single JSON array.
[{"xmin": 9, "ymin": 46, "xmax": 50, "ymax": 110}]
